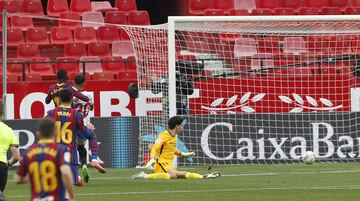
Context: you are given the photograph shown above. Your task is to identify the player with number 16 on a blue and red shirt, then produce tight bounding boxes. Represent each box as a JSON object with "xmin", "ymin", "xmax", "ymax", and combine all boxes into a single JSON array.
[{"xmin": 48, "ymin": 89, "xmax": 106, "ymax": 185}]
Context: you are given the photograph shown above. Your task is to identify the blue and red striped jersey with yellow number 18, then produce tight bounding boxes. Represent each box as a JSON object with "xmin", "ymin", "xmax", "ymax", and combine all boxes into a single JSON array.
[{"xmin": 17, "ymin": 140, "xmax": 70, "ymax": 201}]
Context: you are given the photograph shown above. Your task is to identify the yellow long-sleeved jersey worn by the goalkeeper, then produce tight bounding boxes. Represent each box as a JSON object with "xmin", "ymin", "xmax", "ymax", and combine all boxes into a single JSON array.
[{"xmin": 150, "ymin": 130, "xmax": 181, "ymax": 163}]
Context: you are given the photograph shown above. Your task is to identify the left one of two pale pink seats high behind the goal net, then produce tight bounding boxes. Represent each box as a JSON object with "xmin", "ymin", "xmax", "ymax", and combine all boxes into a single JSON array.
[{"xmin": 234, "ymin": 38, "xmax": 257, "ymax": 57}]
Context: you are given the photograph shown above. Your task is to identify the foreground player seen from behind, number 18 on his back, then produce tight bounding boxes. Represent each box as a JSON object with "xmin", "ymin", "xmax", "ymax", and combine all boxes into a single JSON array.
[{"xmin": 15, "ymin": 118, "xmax": 74, "ymax": 201}]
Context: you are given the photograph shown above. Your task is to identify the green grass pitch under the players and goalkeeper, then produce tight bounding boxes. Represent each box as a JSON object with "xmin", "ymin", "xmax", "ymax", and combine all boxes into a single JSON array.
[{"xmin": 5, "ymin": 163, "xmax": 360, "ymax": 201}]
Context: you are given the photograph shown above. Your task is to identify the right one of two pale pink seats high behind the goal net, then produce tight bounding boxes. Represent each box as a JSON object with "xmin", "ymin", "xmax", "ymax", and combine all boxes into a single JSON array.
[{"xmin": 283, "ymin": 37, "xmax": 307, "ymax": 55}]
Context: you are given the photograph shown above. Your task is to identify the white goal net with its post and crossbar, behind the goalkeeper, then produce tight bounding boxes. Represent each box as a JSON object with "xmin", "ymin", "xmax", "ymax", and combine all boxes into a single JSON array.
[{"xmin": 131, "ymin": 17, "xmax": 360, "ymax": 165}]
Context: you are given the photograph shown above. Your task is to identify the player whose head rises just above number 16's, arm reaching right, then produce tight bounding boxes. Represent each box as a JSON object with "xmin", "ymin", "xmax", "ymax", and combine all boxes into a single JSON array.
[{"xmin": 45, "ymin": 69, "xmax": 89, "ymax": 107}]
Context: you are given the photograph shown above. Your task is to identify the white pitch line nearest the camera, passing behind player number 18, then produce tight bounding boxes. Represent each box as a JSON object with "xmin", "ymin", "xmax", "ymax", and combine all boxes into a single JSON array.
[{"xmin": 6, "ymin": 185, "xmax": 360, "ymax": 198}]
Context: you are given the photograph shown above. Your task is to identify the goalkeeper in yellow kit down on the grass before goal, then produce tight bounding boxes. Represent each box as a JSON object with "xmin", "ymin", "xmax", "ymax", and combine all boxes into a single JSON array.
[{"xmin": 133, "ymin": 116, "xmax": 220, "ymax": 179}]
